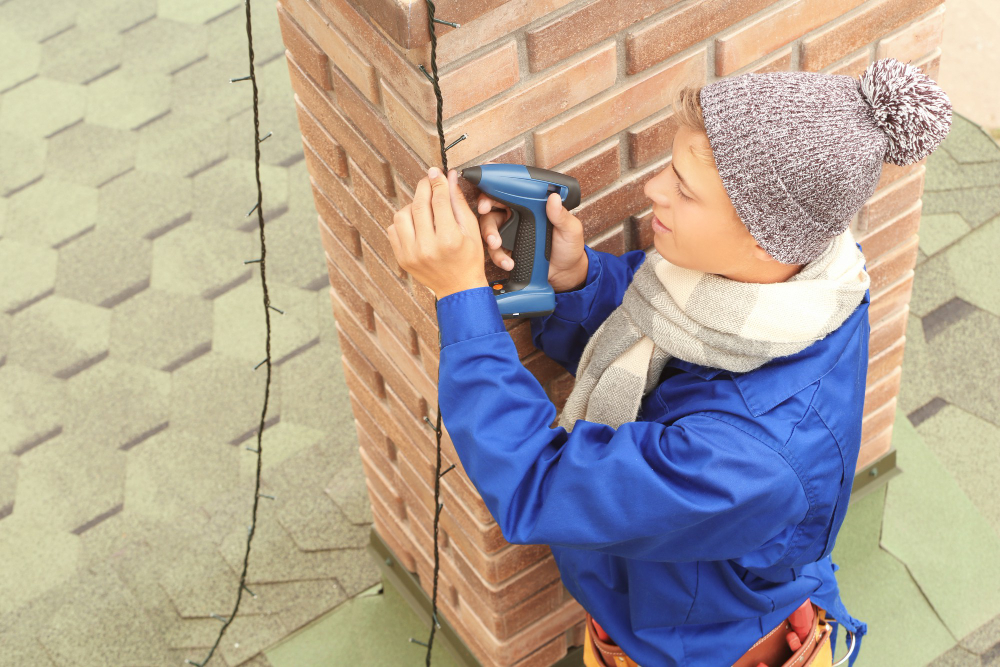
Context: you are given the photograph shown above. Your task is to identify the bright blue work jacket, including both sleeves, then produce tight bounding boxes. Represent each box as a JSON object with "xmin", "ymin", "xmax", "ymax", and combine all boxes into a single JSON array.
[{"xmin": 437, "ymin": 244, "xmax": 870, "ymax": 667}]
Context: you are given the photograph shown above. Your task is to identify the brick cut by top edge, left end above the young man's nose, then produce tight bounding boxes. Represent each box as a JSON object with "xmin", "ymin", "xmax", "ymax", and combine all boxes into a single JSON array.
[{"xmin": 625, "ymin": 0, "xmax": 776, "ymax": 74}]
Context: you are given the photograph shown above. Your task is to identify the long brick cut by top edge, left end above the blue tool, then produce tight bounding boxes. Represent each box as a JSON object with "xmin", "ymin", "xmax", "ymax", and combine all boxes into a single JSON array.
[{"xmin": 524, "ymin": 0, "xmax": 680, "ymax": 72}]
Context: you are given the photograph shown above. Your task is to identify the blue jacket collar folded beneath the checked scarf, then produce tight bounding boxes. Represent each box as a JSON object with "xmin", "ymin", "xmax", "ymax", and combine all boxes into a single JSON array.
[{"xmin": 667, "ymin": 290, "xmax": 871, "ymax": 417}]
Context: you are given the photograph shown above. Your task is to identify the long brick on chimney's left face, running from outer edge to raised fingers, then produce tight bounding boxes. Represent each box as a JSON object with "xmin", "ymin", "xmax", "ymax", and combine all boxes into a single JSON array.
[{"xmin": 288, "ymin": 50, "xmax": 392, "ymax": 192}]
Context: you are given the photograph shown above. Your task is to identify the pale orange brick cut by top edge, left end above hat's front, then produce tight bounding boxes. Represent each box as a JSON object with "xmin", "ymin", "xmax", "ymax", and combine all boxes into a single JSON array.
[{"xmin": 715, "ymin": 0, "xmax": 865, "ymax": 77}]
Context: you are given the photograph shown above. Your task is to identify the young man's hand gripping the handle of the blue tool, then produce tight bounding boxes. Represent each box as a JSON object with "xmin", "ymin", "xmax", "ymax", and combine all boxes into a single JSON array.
[{"xmin": 476, "ymin": 181, "xmax": 588, "ymax": 291}]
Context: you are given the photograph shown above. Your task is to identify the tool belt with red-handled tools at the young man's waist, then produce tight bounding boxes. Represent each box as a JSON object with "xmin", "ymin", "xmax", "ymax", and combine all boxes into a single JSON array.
[{"xmin": 583, "ymin": 600, "xmax": 854, "ymax": 667}]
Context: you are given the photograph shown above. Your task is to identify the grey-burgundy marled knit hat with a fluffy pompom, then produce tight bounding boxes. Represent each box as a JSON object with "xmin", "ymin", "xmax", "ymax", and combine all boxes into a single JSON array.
[{"xmin": 700, "ymin": 58, "xmax": 951, "ymax": 264}]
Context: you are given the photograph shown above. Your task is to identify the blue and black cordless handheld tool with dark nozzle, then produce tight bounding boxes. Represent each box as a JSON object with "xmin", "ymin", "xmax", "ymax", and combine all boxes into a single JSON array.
[{"xmin": 461, "ymin": 164, "xmax": 580, "ymax": 319}]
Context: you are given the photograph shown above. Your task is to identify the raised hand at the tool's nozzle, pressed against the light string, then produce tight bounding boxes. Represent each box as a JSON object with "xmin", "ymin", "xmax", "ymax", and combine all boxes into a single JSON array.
[{"xmin": 387, "ymin": 167, "xmax": 489, "ymax": 299}]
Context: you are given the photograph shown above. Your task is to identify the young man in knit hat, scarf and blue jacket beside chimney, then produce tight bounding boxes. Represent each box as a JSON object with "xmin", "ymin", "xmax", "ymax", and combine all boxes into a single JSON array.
[{"xmin": 388, "ymin": 58, "xmax": 951, "ymax": 667}]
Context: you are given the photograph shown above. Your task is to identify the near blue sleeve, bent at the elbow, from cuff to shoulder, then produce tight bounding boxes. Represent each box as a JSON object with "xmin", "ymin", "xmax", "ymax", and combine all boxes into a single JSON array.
[{"xmin": 438, "ymin": 287, "xmax": 808, "ymax": 561}]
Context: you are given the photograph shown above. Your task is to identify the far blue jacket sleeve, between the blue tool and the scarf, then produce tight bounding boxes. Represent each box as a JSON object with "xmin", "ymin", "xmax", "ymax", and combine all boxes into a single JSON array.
[{"xmin": 530, "ymin": 245, "xmax": 646, "ymax": 377}]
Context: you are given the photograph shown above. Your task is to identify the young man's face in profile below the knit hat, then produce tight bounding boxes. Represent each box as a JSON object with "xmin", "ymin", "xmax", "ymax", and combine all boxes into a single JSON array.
[{"xmin": 644, "ymin": 127, "xmax": 774, "ymax": 280}]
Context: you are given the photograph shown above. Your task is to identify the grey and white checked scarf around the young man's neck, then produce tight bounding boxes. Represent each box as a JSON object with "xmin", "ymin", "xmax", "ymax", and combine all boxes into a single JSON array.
[{"xmin": 559, "ymin": 228, "xmax": 871, "ymax": 431}]
